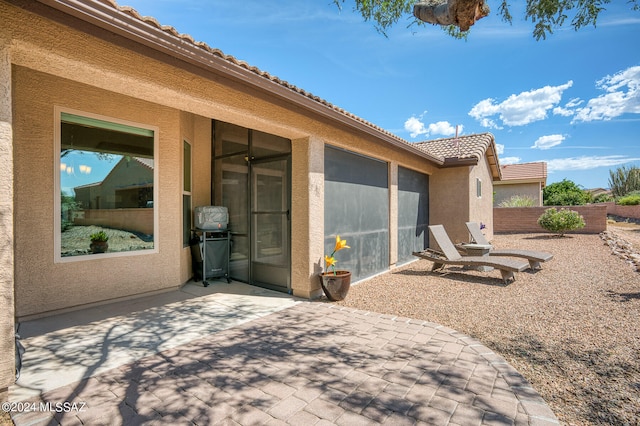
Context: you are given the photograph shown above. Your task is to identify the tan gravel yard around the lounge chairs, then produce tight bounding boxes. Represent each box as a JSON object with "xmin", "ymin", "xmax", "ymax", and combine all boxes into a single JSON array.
[{"xmin": 339, "ymin": 225, "xmax": 640, "ymax": 425}]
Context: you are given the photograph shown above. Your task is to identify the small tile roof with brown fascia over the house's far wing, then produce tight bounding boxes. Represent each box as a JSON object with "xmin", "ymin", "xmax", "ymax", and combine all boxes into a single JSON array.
[{"xmin": 414, "ymin": 133, "xmax": 501, "ymax": 180}]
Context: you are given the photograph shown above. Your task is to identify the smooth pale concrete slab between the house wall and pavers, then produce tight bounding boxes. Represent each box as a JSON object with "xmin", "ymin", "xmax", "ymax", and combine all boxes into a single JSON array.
[{"xmin": 9, "ymin": 282, "xmax": 298, "ymax": 401}]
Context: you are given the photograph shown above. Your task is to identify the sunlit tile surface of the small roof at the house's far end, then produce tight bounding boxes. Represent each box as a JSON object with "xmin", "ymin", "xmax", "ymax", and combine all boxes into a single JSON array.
[{"xmin": 415, "ymin": 133, "xmax": 493, "ymax": 161}]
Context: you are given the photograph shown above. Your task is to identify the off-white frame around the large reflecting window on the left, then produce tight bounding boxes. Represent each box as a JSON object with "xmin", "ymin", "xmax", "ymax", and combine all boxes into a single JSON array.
[{"xmin": 53, "ymin": 106, "xmax": 160, "ymax": 263}]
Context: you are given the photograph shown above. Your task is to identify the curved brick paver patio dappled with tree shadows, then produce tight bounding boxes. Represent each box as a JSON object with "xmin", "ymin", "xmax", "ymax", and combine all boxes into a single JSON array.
[{"xmin": 13, "ymin": 302, "xmax": 558, "ymax": 426}]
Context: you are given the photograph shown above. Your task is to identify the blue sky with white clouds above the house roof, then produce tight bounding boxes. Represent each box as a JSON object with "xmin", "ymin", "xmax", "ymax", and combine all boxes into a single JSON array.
[{"xmin": 119, "ymin": 0, "xmax": 640, "ymax": 188}]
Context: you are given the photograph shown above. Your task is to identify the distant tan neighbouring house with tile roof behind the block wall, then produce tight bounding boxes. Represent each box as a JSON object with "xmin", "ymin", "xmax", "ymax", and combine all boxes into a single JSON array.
[{"xmin": 493, "ymin": 161, "xmax": 547, "ymax": 207}]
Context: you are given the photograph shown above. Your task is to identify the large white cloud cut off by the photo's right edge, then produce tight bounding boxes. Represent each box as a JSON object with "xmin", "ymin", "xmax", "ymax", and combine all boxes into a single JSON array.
[{"xmin": 572, "ymin": 66, "xmax": 640, "ymax": 123}]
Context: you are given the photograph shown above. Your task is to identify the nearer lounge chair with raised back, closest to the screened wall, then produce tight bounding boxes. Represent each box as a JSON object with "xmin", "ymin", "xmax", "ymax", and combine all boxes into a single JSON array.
[{"xmin": 413, "ymin": 225, "xmax": 529, "ymax": 284}]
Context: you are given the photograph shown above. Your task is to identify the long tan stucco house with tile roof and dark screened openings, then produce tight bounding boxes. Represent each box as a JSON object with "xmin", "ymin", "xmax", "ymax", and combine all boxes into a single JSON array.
[{"xmin": 0, "ymin": 0, "xmax": 500, "ymax": 400}]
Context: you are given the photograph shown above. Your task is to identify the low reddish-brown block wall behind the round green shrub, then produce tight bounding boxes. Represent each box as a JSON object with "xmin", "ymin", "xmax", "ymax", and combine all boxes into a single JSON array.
[{"xmin": 493, "ymin": 203, "xmax": 608, "ymax": 234}]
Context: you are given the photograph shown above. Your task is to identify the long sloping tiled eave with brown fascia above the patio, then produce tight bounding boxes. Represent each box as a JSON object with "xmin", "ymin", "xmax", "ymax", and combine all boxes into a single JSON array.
[{"xmin": 28, "ymin": 0, "xmax": 444, "ymax": 167}]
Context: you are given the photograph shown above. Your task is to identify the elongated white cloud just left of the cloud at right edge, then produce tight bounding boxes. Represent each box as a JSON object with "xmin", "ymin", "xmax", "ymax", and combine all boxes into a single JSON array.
[{"xmin": 469, "ymin": 80, "xmax": 573, "ymax": 128}]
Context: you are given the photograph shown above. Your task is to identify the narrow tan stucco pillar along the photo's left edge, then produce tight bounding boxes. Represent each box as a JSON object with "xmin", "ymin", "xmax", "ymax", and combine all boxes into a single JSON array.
[{"xmin": 0, "ymin": 38, "xmax": 15, "ymax": 402}]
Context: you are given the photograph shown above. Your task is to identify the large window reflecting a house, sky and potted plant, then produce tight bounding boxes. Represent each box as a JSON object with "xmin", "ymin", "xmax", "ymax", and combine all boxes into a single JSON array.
[{"xmin": 56, "ymin": 110, "xmax": 157, "ymax": 260}]
